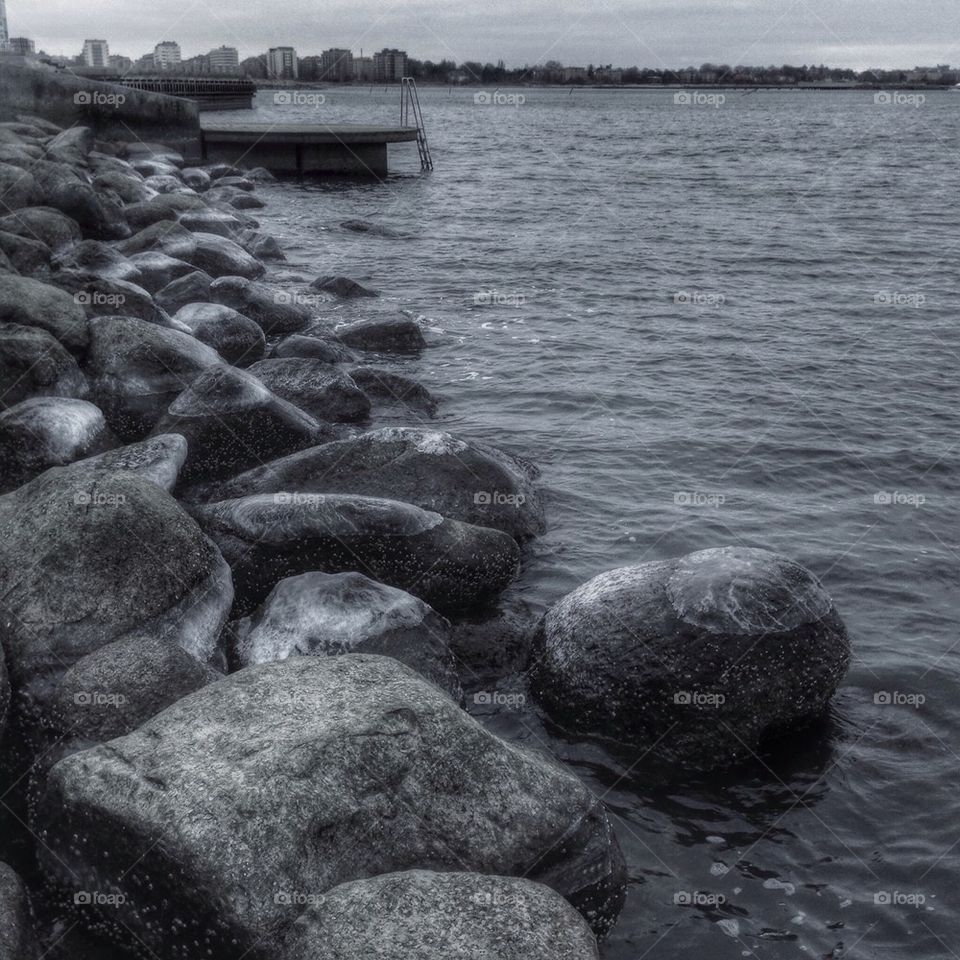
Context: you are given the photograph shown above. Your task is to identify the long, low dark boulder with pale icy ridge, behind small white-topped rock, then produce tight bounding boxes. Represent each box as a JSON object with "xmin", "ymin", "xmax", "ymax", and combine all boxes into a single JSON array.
[{"xmin": 193, "ymin": 492, "xmax": 520, "ymax": 615}]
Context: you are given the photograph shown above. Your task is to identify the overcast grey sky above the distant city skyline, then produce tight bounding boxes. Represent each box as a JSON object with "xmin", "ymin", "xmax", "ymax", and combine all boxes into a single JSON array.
[{"xmin": 13, "ymin": 0, "xmax": 960, "ymax": 69}]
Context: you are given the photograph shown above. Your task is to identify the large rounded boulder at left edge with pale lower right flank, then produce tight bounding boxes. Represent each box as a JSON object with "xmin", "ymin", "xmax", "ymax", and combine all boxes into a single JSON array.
[{"xmin": 0, "ymin": 467, "xmax": 233, "ymax": 713}]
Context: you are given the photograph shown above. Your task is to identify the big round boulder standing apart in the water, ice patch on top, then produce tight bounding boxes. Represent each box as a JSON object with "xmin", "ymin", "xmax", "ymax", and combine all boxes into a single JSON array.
[{"xmin": 531, "ymin": 547, "xmax": 850, "ymax": 769}]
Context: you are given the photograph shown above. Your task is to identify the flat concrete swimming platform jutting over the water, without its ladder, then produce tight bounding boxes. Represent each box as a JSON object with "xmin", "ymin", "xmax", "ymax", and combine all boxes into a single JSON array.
[{"xmin": 200, "ymin": 117, "xmax": 418, "ymax": 178}]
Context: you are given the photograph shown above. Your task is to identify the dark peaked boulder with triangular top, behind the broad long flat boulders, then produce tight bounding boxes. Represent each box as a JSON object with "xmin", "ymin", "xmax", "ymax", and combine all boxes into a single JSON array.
[{"xmin": 154, "ymin": 364, "xmax": 321, "ymax": 482}]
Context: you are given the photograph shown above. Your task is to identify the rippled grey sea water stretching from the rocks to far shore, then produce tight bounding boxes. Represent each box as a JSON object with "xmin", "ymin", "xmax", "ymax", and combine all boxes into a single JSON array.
[{"xmin": 212, "ymin": 89, "xmax": 960, "ymax": 960}]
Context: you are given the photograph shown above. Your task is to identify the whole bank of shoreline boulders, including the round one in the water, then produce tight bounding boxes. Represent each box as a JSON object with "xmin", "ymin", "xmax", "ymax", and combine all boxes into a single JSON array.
[{"xmin": 0, "ymin": 116, "xmax": 849, "ymax": 960}]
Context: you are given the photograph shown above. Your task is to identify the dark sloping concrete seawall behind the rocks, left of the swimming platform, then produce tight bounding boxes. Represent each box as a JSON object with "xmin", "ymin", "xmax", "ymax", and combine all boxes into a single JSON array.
[{"xmin": 0, "ymin": 57, "xmax": 200, "ymax": 157}]
